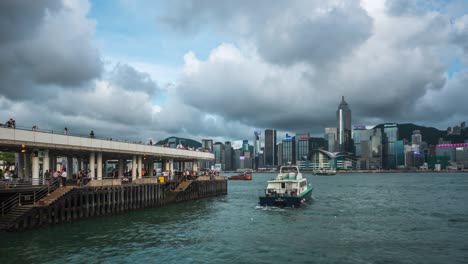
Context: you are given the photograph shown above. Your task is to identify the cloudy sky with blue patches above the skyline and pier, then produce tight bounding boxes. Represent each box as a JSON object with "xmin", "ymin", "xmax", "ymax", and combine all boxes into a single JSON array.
[{"xmin": 0, "ymin": 0, "xmax": 468, "ymax": 147}]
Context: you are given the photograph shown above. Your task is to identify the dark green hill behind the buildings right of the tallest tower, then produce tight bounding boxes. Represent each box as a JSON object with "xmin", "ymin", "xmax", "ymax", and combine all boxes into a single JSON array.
[{"xmin": 374, "ymin": 123, "xmax": 446, "ymax": 145}]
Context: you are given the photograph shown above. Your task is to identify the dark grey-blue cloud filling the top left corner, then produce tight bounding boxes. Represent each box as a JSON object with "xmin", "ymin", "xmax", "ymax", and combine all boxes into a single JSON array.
[{"xmin": 0, "ymin": 1, "xmax": 102, "ymax": 99}]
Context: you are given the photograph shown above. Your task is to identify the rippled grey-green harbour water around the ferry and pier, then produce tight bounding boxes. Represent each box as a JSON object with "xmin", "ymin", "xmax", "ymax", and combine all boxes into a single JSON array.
[{"xmin": 0, "ymin": 173, "xmax": 468, "ymax": 263}]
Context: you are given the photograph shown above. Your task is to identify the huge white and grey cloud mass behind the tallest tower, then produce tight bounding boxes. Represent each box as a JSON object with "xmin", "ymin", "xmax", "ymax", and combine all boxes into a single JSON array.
[{"xmin": 165, "ymin": 1, "xmax": 466, "ymax": 134}]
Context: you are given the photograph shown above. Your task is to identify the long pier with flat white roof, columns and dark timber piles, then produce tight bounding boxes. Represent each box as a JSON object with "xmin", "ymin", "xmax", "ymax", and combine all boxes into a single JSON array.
[{"xmin": 0, "ymin": 127, "xmax": 227, "ymax": 231}]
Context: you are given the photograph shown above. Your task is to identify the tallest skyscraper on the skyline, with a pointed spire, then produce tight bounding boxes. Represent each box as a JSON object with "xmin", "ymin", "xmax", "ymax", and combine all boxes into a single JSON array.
[{"xmin": 336, "ymin": 96, "xmax": 352, "ymax": 152}]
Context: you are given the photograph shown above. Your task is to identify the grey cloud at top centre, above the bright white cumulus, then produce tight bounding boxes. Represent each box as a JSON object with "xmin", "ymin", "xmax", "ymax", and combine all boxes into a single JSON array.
[{"xmin": 161, "ymin": 1, "xmax": 372, "ymax": 67}]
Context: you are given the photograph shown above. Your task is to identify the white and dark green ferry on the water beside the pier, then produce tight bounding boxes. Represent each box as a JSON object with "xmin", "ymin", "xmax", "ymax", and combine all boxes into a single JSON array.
[{"xmin": 259, "ymin": 165, "xmax": 313, "ymax": 207}]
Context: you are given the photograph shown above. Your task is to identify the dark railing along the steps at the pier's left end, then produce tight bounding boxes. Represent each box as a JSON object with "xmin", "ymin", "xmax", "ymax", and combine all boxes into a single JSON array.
[{"xmin": 0, "ymin": 179, "xmax": 60, "ymax": 216}]
